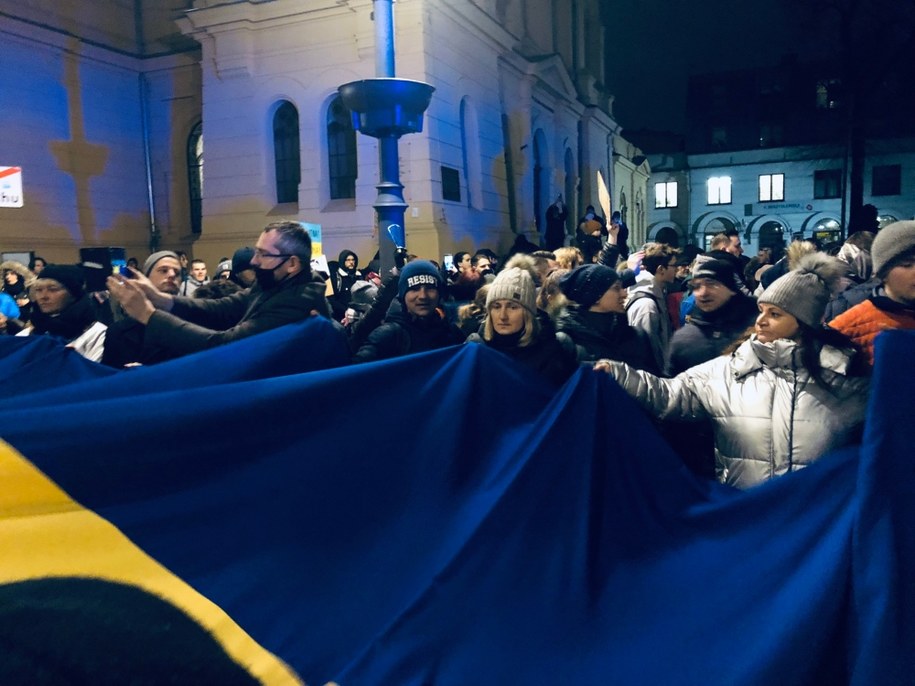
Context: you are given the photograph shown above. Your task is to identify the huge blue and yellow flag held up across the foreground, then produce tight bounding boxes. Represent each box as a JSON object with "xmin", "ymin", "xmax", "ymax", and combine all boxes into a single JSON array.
[{"xmin": 0, "ymin": 327, "xmax": 915, "ymax": 685}]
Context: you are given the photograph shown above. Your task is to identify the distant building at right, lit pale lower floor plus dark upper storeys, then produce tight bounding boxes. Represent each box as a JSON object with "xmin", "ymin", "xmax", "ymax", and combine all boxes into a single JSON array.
[{"xmin": 648, "ymin": 60, "xmax": 915, "ymax": 252}]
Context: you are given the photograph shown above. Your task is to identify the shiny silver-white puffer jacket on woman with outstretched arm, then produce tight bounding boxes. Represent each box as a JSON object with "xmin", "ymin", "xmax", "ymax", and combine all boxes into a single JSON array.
[{"xmin": 610, "ymin": 335, "xmax": 869, "ymax": 488}]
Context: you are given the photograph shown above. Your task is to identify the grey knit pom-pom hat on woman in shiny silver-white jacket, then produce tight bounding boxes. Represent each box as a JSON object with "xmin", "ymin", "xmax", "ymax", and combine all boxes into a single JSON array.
[{"xmin": 758, "ymin": 252, "xmax": 845, "ymax": 328}]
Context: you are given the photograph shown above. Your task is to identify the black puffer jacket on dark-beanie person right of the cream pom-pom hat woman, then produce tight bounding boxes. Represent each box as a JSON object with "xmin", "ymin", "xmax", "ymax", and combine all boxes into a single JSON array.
[{"xmin": 556, "ymin": 303, "xmax": 658, "ymax": 373}]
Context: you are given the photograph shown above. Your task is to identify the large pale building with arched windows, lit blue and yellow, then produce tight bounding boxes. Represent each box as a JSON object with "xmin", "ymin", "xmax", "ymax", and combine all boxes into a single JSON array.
[{"xmin": 0, "ymin": 0, "xmax": 647, "ymax": 272}]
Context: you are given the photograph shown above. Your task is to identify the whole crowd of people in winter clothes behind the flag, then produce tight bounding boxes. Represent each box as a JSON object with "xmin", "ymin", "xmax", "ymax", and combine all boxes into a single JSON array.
[{"xmin": 0, "ymin": 218, "xmax": 915, "ymax": 488}]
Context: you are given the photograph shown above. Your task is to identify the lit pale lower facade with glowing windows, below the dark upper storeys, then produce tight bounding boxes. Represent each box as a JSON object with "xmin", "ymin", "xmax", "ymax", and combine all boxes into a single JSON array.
[{"xmin": 648, "ymin": 138, "xmax": 915, "ymax": 253}]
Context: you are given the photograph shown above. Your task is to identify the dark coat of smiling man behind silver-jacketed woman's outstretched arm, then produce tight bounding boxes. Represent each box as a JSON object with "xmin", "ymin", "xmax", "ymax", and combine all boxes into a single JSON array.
[{"xmin": 667, "ymin": 293, "xmax": 758, "ymax": 376}]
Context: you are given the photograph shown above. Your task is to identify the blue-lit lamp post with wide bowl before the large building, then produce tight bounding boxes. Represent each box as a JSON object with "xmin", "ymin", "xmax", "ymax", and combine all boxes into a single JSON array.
[{"xmin": 338, "ymin": 0, "xmax": 435, "ymax": 273}]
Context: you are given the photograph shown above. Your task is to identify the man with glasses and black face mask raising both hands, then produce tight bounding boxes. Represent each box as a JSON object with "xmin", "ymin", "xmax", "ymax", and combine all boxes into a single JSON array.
[{"xmin": 108, "ymin": 222, "xmax": 330, "ymax": 356}]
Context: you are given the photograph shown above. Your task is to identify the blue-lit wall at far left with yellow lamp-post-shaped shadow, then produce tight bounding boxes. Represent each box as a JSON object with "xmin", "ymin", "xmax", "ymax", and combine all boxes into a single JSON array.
[{"xmin": 0, "ymin": 15, "xmax": 199, "ymax": 262}]
